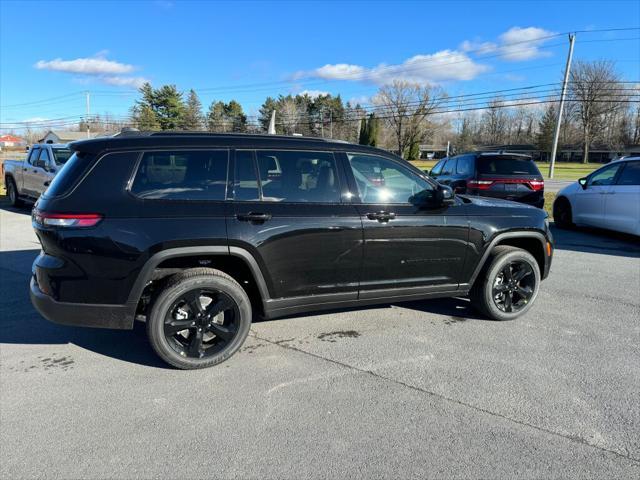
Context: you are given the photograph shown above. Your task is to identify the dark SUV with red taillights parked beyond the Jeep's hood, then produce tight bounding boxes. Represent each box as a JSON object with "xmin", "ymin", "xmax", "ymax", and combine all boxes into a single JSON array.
[{"xmin": 429, "ymin": 152, "xmax": 544, "ymax": 208}]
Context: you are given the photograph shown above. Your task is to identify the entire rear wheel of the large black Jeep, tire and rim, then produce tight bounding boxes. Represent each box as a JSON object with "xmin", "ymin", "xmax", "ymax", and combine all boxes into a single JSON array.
[{"xmin": 147, "ymin": 268, "xmax": 252, "ymax": 370}]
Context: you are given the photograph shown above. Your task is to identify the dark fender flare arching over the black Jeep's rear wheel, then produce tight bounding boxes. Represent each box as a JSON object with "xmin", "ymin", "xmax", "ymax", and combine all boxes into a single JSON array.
[{"xmin": 127, "ymin": 245, "xmax": 270, "ymax": 305}]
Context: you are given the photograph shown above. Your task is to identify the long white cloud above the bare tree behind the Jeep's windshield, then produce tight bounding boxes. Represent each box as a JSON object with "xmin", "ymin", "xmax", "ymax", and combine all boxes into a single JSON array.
[{"xmin": 294, "ymin": 50, "xmax": 489, "ymax": 85}]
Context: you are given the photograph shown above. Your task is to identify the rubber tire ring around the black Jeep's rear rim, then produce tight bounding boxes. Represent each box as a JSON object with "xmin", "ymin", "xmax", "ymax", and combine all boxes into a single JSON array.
[{"xmin": 147, "ymin": 275, "xmax": 251, "ymax": 369}]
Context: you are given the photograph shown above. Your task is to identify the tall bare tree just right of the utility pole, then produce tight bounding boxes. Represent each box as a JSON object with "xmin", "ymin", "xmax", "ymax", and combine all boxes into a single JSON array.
[{"xmin": 569, "ymin": 60, "xmax": 624, "ymax": 163}]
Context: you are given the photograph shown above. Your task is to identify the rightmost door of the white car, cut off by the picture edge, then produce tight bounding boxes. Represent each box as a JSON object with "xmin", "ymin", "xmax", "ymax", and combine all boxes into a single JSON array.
[{"xmin": 604, "ymin": 160, "xmax": 640, "ymax": 235}]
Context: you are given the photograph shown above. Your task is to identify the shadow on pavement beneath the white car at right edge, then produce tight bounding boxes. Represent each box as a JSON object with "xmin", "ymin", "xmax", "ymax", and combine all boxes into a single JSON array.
[{"xmin": 551, "ymin": 225, "xmax": 640, "ymax": 258}]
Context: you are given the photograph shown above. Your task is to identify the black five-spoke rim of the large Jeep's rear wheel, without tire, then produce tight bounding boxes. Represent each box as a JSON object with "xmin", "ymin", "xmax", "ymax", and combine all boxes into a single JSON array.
[{"xmin": 164, "ymin": 288, "xmax": 240, "ymax": 359}]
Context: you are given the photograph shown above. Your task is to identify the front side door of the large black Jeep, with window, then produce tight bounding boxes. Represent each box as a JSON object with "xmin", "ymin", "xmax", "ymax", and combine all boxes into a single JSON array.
[{"xmin": 344, "ymin": 152, "xmax": 469, "ymax": 299}]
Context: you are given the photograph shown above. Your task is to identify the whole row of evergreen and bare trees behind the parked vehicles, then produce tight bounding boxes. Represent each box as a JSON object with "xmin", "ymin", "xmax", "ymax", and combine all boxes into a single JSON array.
[{"xmin": 119, "ymin": 61, "xmax": 640, "ymax": 161}]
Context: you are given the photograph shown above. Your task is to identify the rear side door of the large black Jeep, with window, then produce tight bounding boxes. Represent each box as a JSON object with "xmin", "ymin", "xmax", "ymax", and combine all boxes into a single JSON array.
[{"xmin": 227, "ymin": 149, "xmax": 362, "ymax": 301}]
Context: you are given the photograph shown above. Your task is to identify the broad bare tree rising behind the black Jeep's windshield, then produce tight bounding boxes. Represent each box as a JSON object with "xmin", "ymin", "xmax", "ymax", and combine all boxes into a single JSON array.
[{"xmin": 375, "ymin": 80, "xmax": 445, "ymax": 156}]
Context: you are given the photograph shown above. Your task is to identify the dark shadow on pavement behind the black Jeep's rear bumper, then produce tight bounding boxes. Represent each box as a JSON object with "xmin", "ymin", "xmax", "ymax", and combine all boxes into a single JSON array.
[{"xmin": 0, "ymin": 250, "xmax": 169, "ymax": 368}]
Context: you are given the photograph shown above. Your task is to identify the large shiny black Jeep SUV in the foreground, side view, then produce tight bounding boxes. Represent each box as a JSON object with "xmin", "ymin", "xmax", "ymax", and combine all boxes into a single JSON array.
[{"xmin": 31, "ymin": 133, "xmax": 552, "ymax": 368}]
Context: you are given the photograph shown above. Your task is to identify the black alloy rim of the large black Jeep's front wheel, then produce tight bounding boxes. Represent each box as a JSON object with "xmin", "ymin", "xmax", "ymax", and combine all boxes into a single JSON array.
[{"xmin": 492, "ymin": 261, "xmax": 536, "ymax": 313}]
